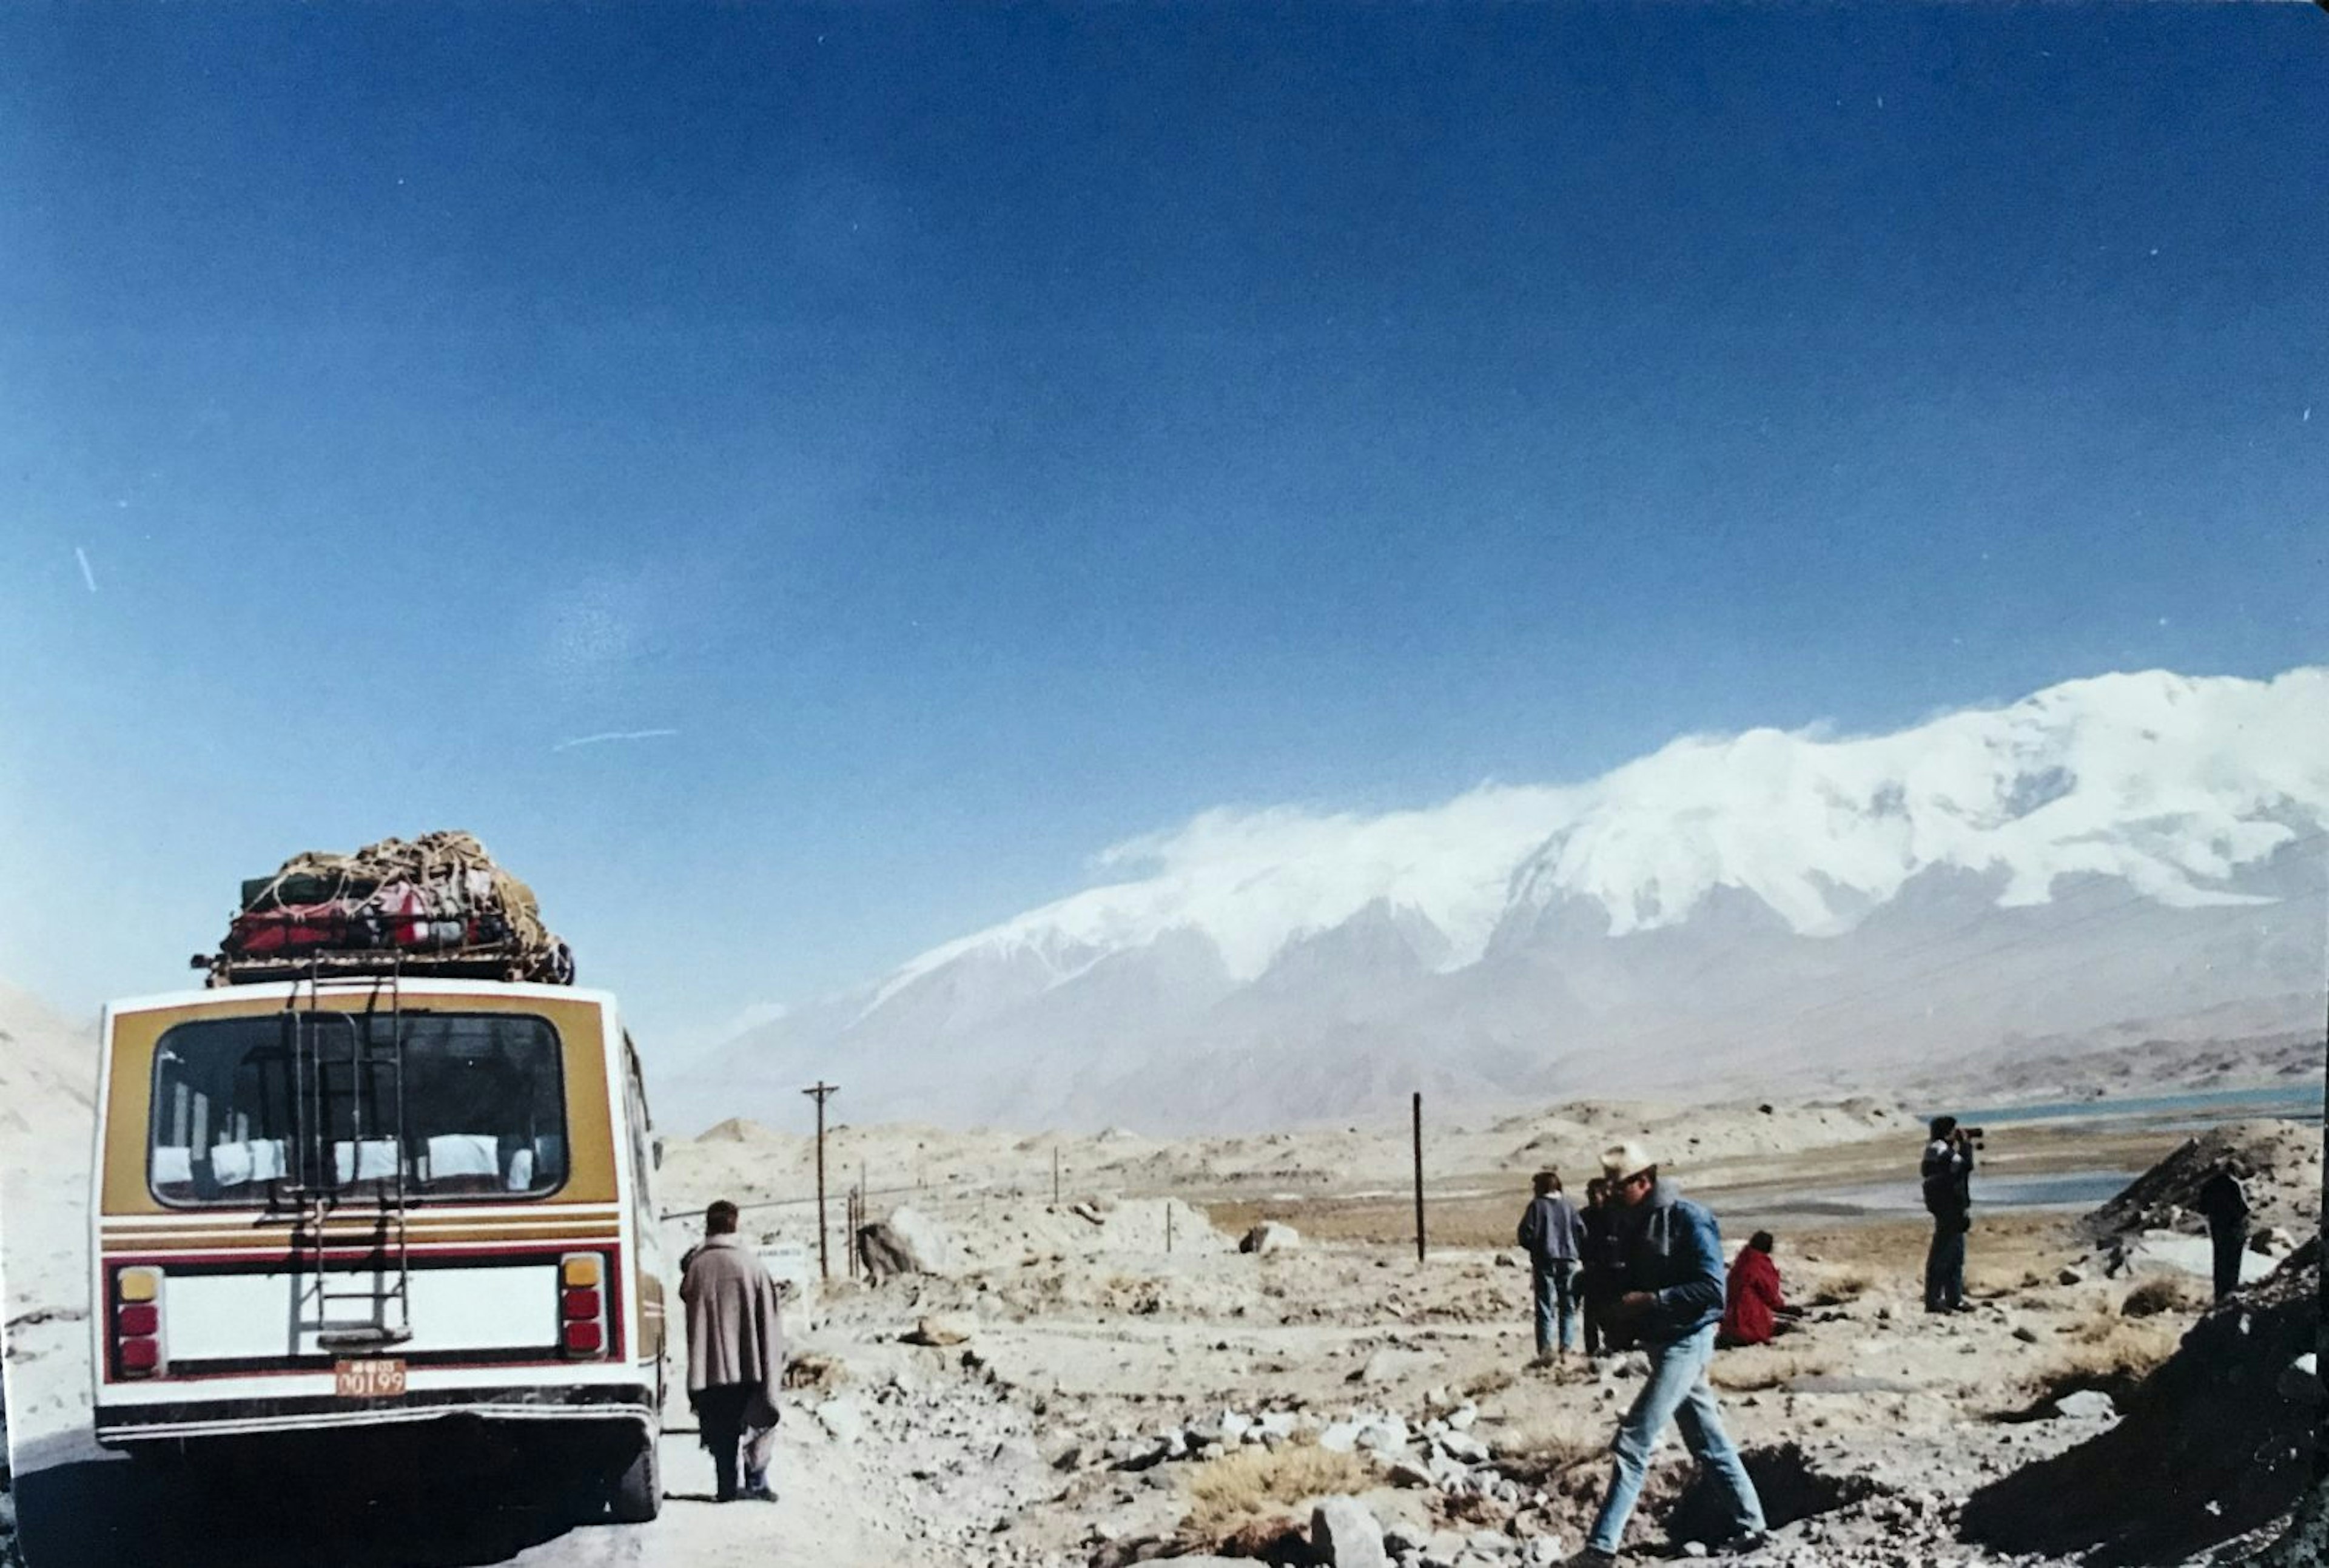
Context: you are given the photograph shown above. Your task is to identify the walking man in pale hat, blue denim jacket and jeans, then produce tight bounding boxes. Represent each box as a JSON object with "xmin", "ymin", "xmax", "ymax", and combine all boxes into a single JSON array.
[{"xmin": 1570, "ymin": 1142, "xmax": 1763, "ymax": 1568}]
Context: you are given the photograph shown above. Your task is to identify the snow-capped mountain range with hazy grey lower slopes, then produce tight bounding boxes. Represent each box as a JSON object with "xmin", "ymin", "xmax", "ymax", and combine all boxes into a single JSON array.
[{"xmin": 676, "ymin": 668, "xmax": 2329, "ymax": 1125}]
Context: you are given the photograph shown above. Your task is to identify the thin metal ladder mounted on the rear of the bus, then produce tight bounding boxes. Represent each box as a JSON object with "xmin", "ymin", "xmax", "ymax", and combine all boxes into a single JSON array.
[{"xmin": 284, "ymin": 972, "xmax": 412, "ymax": 1351}]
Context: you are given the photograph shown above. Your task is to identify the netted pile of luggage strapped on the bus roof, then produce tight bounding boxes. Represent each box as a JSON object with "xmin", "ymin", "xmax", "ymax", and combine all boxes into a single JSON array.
[{"xmin": 193, "ymin": 832, "xmax": 575, "ymax": 986}]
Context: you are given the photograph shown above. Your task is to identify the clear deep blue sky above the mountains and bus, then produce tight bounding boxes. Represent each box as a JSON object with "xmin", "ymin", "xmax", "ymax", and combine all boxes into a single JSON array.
[{"xmin": 0, "ymin": 5, "xmax": 2329, "ymax": 1062}]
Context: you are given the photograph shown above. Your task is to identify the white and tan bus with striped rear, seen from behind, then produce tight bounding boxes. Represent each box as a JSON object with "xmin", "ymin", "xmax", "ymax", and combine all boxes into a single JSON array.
[{"xmin": 89, "ymin": 969, "xmax": 666, "ymax": 1521}]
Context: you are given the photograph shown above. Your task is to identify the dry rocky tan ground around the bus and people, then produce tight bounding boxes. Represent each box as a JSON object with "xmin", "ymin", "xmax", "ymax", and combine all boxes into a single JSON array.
[{"xmin": 7, "ymin": 1076, "xmax": 2320, "ymax": 1568}]
